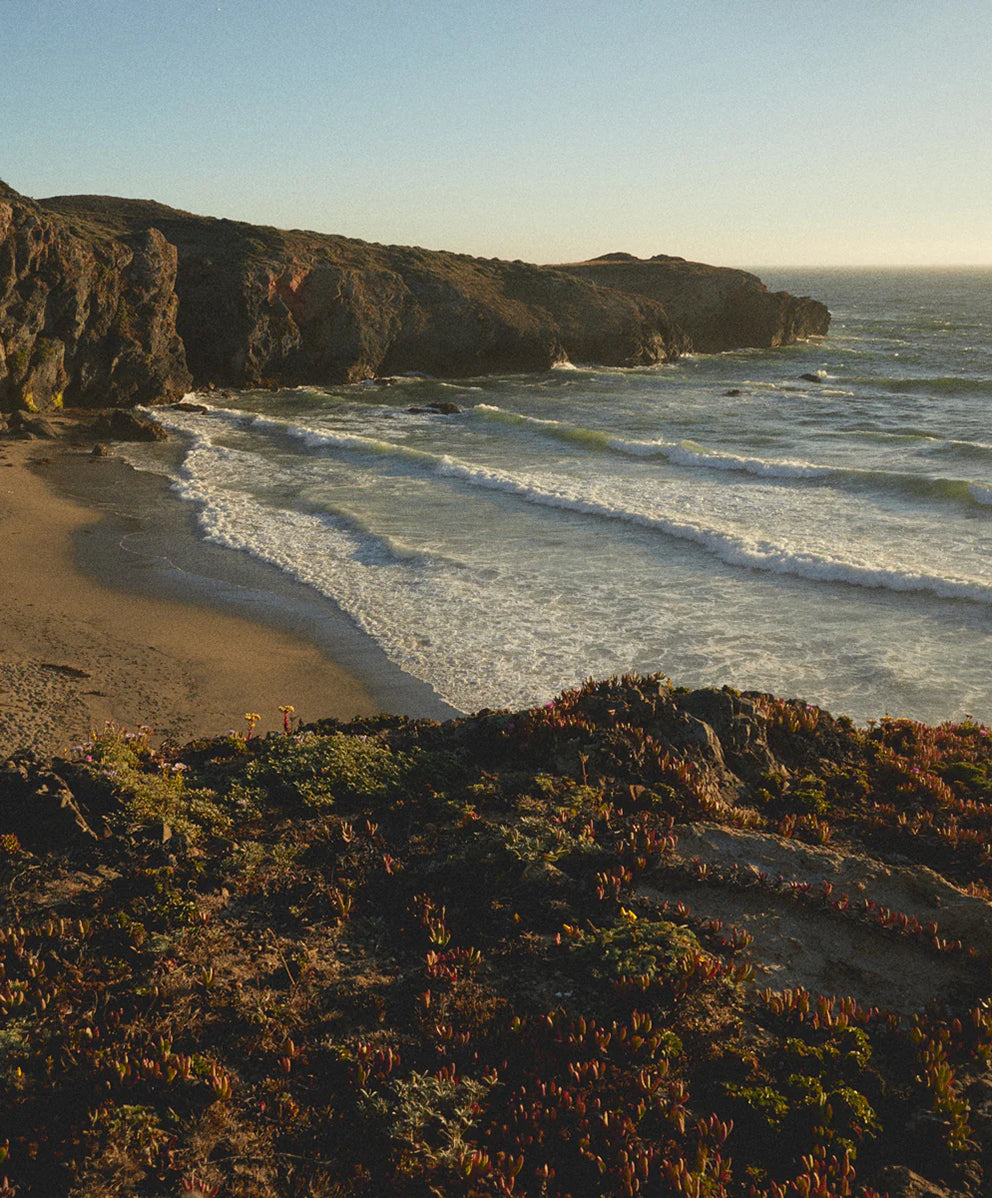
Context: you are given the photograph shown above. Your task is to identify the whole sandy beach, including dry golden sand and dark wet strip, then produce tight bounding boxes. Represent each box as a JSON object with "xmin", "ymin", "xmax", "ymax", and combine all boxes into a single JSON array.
[{"xmin": 0, "ymin": 416, "xmax": 456, "ymax": 760}]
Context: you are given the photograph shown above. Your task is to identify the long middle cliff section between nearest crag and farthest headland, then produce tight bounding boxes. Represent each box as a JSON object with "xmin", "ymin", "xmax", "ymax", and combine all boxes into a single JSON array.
[{"xmin": 44, "ymin": 196, "xmax": 681, "ymax": 386}]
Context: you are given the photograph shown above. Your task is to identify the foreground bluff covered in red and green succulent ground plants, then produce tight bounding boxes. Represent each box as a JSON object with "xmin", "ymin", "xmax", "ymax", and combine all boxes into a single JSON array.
[{"xmin": 0, "ymin": 676, "xmax": 992, "ymax": 1198}]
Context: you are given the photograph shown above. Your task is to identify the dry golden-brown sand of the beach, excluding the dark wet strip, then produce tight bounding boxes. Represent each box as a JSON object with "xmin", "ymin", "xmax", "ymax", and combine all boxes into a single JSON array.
[{"xmin": 0, "ymin": 420, "xmax": 390, "ymax": 760}]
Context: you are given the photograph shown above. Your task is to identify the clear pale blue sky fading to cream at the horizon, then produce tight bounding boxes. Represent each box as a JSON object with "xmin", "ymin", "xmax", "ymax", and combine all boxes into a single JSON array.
[{"xmin": 0, "ymin": 0, "xmax": 992, "ymax": 265}]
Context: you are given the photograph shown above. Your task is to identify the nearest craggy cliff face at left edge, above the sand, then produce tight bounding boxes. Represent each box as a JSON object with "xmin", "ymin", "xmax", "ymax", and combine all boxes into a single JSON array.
[{"xmin": 0, "ymin": 183, "xmax": 190, "ymax": 411}]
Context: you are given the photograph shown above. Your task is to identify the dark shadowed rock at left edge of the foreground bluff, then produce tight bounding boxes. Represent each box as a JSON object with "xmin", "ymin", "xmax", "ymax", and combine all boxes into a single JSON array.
[{"xmin": 0, "ymin": 754, "xmax": 96, "ymax": 853}]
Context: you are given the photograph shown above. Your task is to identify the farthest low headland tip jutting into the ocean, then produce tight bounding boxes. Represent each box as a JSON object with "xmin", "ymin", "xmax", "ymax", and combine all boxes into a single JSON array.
[{"xmin": 555, "ymin": 254, "xmax": 830, "ymax": 353}]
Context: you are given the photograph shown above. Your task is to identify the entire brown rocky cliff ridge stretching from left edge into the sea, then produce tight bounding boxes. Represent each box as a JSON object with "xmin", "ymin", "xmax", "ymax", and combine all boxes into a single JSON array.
[{"xmin": 0, "ymin": 183, "xmax": 829, "ymax": 411}]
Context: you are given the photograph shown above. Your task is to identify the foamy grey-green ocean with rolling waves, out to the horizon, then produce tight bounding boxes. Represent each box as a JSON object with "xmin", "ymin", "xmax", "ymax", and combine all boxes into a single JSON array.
[{"xmin": 121, "ymin": 268, "xmax": 992, "ymax": 724}]
